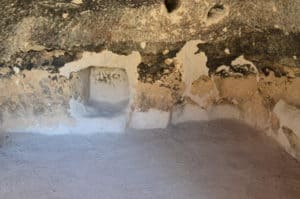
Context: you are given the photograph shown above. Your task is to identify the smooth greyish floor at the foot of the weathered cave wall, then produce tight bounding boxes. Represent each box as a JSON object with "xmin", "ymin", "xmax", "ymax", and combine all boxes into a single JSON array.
[{"xmin": 0, "ymin": 120, "xmax": 300, "ymax": 199}]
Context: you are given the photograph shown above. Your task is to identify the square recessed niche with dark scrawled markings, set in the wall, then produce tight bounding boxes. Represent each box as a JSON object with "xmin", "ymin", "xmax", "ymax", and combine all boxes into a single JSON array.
[{"xmin": 79, "ymin": 67, "xmax": 130, "ymax": 117}]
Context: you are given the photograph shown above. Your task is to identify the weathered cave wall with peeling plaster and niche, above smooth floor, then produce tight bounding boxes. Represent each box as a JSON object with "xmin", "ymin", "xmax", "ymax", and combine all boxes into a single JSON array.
[{"xmin": 0, "ymin": 0, "xmax": 300, "ymax": 159}]
